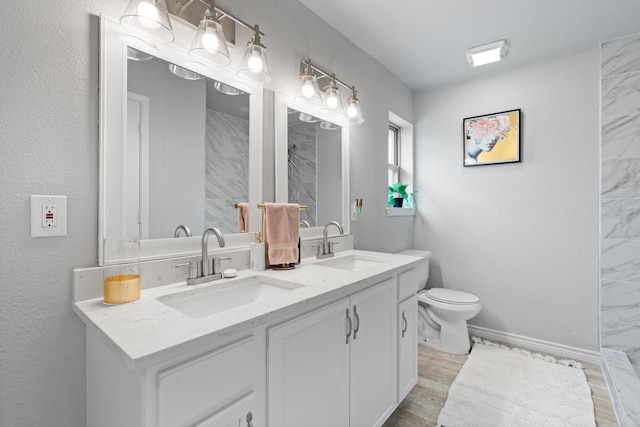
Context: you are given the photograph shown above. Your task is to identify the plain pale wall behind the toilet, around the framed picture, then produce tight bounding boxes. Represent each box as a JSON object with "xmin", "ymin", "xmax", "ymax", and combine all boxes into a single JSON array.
[{"xmin": 414, "ymin": 46, "xmax": 600, "ymax": 350}]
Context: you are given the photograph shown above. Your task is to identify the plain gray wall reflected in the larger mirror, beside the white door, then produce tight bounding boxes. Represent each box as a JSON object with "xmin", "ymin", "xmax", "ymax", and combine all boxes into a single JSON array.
[{"xmin": 128, "ymin": 60, "xmax": 207, "ymax": 239}]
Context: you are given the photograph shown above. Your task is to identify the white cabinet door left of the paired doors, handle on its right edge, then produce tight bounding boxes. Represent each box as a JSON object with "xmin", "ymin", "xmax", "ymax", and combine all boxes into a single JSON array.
[{"xmin": 267, "ymin": 299, "xmax": 351, "ymax": 427}]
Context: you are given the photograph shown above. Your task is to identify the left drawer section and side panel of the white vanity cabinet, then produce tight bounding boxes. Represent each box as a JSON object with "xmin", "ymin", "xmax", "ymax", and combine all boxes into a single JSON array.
[{"xmin": 87, "ymin": 329, "xmax": 265, "ymax": 427}]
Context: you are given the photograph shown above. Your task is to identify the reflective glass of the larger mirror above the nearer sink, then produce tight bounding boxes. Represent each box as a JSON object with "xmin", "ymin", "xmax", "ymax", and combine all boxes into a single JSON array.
[{"xmin": 123, "ymin": 48, "xmax": 249, "ymax": 240}]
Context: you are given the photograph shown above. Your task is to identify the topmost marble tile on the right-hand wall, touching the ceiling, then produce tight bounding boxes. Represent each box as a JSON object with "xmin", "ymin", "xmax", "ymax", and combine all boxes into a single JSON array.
[{"xmin": 600, "ymin": 34, "xmax": 640, "ymax": 77}]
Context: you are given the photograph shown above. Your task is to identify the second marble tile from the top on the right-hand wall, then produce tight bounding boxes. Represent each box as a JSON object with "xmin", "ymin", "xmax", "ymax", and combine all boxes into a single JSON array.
[{"xmin": 601, "ymin": 72, "xmax": 640, "ymax": 119}]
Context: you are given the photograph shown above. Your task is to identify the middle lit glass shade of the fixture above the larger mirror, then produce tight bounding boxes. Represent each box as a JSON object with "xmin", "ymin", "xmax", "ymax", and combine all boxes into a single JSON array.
[{"xmin": 189, "ymin": 14, "xmax": 231, "ymax": 66}]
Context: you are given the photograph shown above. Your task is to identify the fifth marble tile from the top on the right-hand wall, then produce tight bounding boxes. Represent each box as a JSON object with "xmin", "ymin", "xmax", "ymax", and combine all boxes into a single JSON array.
[{"xmin": 600, "ymin": 199, "xmax": 640, "ymax": 239}]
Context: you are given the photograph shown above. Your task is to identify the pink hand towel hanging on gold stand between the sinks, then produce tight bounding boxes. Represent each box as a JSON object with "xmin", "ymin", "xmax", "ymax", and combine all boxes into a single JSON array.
[{"xmin": 262, "ymin": 203, "xmax": 300, "ymax": 266}]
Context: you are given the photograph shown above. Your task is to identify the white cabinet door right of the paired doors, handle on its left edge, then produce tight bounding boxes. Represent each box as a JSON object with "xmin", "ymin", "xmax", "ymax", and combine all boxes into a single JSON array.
[{"xmin": 349, "ymin": 279, "xmax": 397, "ymax": 427}]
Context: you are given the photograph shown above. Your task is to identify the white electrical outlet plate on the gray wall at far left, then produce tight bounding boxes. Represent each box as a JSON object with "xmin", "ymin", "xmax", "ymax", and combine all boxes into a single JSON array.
[{"xmin": 31, "ymin": 195, "xmax": 67, "ymax": 237}]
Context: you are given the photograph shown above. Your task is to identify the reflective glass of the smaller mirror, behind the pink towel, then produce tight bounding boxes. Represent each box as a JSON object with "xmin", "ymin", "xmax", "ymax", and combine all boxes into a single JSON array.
[{"xmin": 287, "ymin": 108, "xmax": 342, "ymax": 228}]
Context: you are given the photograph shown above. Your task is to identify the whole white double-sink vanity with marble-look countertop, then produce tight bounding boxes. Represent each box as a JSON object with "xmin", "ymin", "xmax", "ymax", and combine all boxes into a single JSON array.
[{"xmin": 74, "ymin": 249, "xmax": 425, "ymax": 427}]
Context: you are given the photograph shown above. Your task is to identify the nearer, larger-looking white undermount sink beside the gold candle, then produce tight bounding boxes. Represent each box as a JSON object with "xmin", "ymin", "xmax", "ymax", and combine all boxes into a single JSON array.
[{"xmin": 157, "ymin": 276, "xmax": 302, "ymax": 317}]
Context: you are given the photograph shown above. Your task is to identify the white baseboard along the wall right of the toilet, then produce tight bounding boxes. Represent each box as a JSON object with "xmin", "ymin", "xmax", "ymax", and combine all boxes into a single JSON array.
[{"xmin": 469, "ymin": 325, "xmax": 602, "ymax": 365}]
